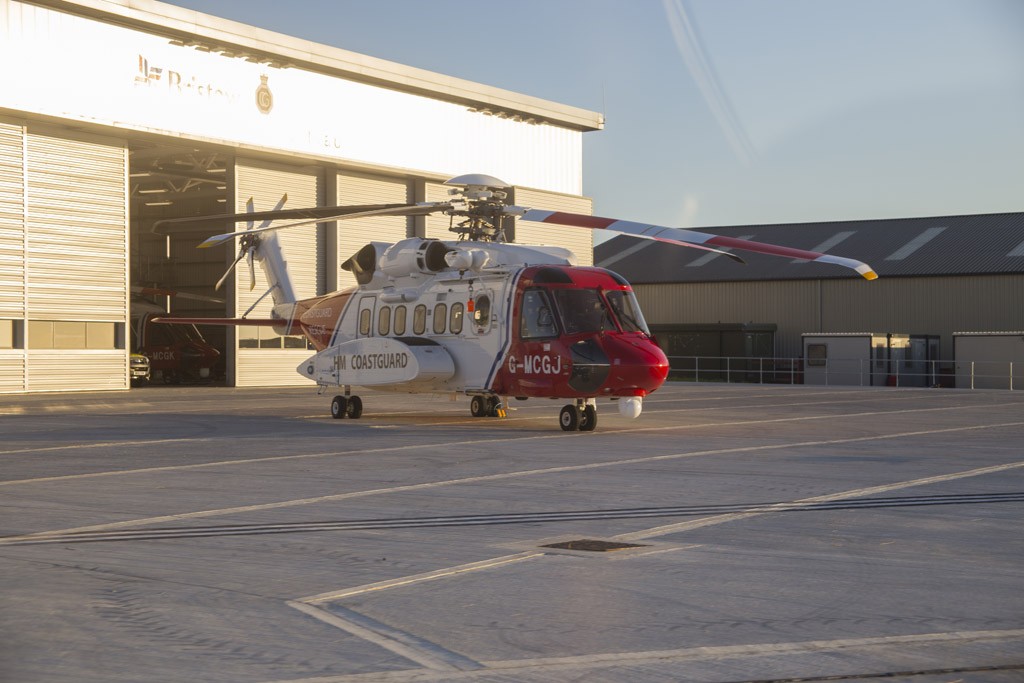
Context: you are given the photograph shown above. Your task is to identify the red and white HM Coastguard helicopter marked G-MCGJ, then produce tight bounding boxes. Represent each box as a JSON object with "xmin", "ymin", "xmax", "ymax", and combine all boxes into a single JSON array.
[{"xmin": 154, "ymin": 174, "xmax": 877, "ymax": 431}]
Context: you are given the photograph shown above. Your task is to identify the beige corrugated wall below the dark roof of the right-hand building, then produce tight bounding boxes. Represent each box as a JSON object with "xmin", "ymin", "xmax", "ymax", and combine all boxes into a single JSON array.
[{"xmin": 635, "ymin": 275, "xmax": 1024, "ymax": 359}]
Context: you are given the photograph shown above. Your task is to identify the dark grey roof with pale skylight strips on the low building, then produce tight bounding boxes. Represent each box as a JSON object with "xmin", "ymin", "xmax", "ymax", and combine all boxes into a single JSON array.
[{"xmin": 594, "ymin": 213, "xmax": 1024, "ymax": 284}]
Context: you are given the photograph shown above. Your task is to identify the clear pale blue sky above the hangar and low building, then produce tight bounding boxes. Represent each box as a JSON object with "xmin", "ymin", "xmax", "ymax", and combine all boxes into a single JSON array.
[{"xmin": 170, "ymin": 0, "xmax": 1024, "ymax": 232}]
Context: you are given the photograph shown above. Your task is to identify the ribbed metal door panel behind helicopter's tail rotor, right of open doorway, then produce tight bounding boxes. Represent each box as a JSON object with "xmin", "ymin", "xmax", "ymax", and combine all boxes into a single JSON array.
[{"xmin": 234, "ymin": 159, "xmax": 325, "ymax": 386}]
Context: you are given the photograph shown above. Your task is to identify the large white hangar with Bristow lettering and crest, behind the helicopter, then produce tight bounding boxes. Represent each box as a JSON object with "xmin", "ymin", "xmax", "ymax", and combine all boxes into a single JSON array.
[{"xmin": 0, "ymin": 0, "xmax": 602, "ymax": 392}]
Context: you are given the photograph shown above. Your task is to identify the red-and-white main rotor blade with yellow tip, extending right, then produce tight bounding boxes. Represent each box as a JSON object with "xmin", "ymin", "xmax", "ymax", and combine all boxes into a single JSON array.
[{"xmin": 520, "ymin": 209, "xmax": 878, "ymax": 280}]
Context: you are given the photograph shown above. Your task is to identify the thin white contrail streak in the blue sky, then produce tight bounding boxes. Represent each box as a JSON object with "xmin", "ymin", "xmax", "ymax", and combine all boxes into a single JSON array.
[{"xmin": 662, "ymin": 0, "xmax": 758, "ymax": 166}]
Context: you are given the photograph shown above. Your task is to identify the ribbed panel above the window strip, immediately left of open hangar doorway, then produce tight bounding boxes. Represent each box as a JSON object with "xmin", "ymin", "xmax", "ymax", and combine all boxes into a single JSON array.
[{"xmin": 27, "ymin": 130, "xmax": 128, "ymax": 323}]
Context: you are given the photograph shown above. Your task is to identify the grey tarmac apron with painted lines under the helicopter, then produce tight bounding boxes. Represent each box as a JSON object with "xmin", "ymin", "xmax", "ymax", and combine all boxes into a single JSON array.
[{"xmin": 0, "ymin": 384, "xmax": 1024, "ymax": 683}]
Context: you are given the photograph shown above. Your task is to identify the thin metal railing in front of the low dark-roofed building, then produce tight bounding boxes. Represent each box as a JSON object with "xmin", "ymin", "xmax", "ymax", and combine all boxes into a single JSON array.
[{"xmin": 669, "ymin": 355, "xmax": 1024, "ymax": 391}]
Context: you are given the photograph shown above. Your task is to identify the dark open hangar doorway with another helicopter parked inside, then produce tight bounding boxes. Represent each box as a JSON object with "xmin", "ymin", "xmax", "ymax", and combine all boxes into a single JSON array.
[{"xmin": 128, "ymin": 142, "xmax": 234, "ymax": 385}]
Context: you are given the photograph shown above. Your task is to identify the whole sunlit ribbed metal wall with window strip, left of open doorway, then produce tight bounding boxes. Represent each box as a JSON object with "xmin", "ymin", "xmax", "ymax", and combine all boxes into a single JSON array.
[{"xmin": 0, "ymin": 123, "xmax": 128, "ymax": 391}]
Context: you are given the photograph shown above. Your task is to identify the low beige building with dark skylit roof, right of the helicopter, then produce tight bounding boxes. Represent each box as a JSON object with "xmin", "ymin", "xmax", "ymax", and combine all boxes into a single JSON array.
[{"xmin": 594, "ymin": 213, "xmax": 1024, "ymax": 376}]
